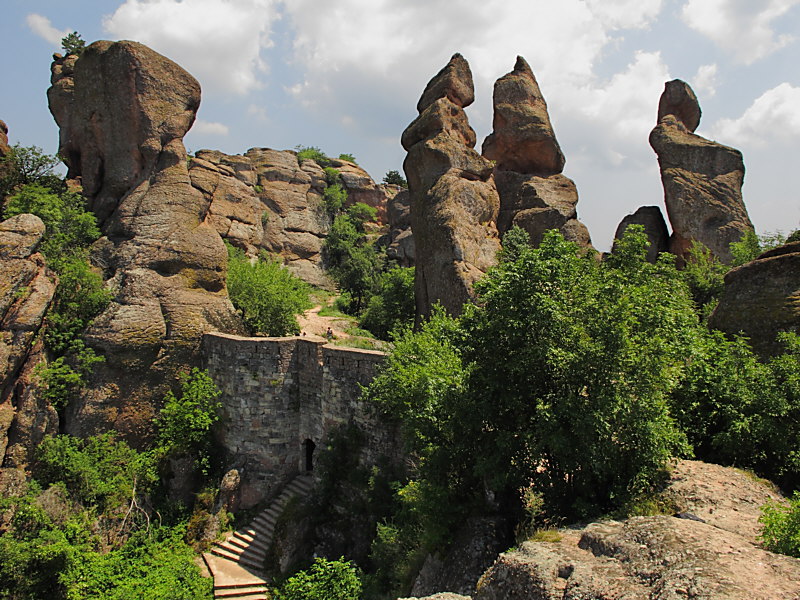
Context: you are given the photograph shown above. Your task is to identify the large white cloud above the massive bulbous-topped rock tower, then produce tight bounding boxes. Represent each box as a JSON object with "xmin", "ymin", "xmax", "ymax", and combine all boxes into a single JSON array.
[{"xmin": 103, "ymin": 0, "xmax": 279, "ymax": 94}]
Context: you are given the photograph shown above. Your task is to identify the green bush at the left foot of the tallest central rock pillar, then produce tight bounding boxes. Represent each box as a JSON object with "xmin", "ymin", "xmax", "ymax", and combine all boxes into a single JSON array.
[{"xmin": 361, "ymin": 267, "xmax": 415, "ymax": 340}]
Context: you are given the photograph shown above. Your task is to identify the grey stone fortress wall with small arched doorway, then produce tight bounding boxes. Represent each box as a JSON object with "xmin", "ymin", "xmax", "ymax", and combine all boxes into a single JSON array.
[{"xmin": 203, "ymin": 333, "xmax": 401, "ymax": 508}]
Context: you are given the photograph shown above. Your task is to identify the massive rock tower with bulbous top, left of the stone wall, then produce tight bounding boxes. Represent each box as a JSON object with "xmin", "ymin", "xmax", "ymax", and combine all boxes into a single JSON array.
[{"xmin": 48, "ymin": 41, "xmax": 239, "ymax": 441}]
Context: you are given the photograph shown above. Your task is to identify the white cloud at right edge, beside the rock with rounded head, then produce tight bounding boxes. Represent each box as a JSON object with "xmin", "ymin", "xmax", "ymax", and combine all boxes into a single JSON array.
[{"xmin": 712, "ymin": 83, "xmax": 800, "ymax": 148}]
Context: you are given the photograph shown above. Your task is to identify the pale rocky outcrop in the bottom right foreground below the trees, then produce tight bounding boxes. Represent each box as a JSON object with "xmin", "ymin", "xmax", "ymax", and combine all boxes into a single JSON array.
[{"xmin": 406, "ymin": 461, "xmax": 800, "ymax": 600}]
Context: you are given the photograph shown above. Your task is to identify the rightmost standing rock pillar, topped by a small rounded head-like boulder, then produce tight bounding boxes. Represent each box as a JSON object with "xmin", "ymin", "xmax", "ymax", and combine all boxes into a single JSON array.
[{"xmin": 650, "ymin": 79, "xmax": 753, "ymax": 263}]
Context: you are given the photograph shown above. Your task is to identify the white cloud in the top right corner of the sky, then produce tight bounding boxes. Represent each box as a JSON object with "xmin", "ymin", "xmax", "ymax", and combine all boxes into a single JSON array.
[{"xmin": 681, "ymin": 0, "xmax": 800, "ymax": 65}]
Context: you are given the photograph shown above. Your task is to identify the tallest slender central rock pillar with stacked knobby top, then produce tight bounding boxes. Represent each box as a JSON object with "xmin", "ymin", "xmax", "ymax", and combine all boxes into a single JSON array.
[{"xmin": 401, "ymin": 54, "xmax": 500, "ymax": 317}]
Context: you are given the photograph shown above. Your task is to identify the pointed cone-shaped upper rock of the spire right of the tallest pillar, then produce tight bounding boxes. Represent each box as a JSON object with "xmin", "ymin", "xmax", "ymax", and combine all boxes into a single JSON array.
[{"xmin": 483, "ymin": 56, "xmax": 565, "ymax": 176}]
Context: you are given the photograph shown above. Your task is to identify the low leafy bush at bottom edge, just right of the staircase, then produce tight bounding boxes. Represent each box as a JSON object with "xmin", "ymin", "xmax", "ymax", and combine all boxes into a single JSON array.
[{"xmin": 276, "ymin": 557, "xmax": 361, "ymax": 600}]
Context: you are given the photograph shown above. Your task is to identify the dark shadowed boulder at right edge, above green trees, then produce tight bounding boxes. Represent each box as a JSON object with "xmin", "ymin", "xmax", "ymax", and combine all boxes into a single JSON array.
[{"xmin": 709, "ymin": 242, "xmax": 800, "ymax": 355}]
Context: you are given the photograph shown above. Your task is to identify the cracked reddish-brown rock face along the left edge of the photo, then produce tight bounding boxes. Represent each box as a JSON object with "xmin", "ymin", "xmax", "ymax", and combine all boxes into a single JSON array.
[{"xmin": 0, "ymin": 215, "xmax": 58, "ymax": 467}]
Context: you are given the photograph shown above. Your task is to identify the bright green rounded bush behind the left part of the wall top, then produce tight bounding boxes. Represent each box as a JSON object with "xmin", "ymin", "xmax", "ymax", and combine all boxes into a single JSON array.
[{"xmin": 228, "ymin": 245, "xmax": 310, "ymax": 336}]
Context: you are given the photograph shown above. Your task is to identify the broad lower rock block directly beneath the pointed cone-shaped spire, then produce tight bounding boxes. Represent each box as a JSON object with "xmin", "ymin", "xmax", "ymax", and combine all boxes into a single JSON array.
[{"xmin": 494, "ymin": 171, "xmax": 592, "ymax": 247}]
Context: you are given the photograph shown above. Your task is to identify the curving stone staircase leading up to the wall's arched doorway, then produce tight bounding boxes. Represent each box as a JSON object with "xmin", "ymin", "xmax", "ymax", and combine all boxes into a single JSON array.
[{"xmin": 203, "ymin": 474, "xmax": 314, "ymax": 600}]
